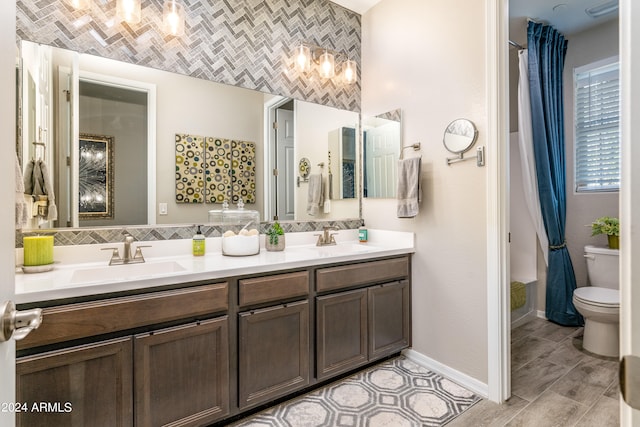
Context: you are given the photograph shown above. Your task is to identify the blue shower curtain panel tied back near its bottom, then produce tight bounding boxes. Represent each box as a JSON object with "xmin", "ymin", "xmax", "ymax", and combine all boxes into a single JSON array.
[{"xmin": 527, "ymin": 22, "xmax": 584, "ymax": 326}]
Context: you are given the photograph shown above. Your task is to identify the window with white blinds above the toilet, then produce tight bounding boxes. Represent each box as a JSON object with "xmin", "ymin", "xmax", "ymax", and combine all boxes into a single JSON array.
[{"xmin": 574, "ymin": 58, "xmax": 620, "ymax": 192}]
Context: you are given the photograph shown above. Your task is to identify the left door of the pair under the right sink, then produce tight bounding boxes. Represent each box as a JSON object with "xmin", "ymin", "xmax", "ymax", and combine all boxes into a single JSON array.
[{"xmin": 316, "ymin": 289, "xmax": 368, "ymax": 379}]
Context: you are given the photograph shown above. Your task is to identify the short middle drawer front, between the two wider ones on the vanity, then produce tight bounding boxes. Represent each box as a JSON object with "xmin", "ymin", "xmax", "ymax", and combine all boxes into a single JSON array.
[{"xmin": 238, "ymin": 271, "xmax": 309, "ymax": 307}]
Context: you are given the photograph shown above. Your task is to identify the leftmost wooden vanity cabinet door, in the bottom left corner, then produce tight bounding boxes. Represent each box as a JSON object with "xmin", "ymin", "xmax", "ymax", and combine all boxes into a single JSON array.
[{"xmin": 16, "ymin": 338, "xmax": 133, "ymax": 427}]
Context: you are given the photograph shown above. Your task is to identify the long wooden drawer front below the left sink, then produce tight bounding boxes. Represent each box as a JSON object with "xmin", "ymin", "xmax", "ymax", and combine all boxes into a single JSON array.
[{"xmin": 17, "ymin": 282, "xmax": 229, "ymax": 349}]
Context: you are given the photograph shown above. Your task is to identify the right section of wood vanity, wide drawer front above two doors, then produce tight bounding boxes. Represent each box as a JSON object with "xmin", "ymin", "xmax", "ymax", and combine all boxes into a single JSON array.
[{"xmin": 316, "ymin": 257, "xmax": 411, "ymax": 379}]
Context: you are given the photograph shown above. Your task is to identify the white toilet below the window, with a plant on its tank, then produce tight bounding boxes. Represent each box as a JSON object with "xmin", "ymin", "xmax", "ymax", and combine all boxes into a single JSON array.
[{"xmin": 573, "ymin": 246, "xmax": 620, "ymax": 357}]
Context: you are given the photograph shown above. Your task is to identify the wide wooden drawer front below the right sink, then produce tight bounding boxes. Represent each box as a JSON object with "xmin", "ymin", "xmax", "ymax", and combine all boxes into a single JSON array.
[{"xmin": 316, "ymin": 257, "xmax": 409, "ymax": 292}]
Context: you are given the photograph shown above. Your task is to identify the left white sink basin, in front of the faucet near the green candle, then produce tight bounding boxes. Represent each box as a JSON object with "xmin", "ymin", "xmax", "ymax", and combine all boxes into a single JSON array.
[{"xmin": 71, "ymin": 261, "xmax": 186, "ymax": 284}]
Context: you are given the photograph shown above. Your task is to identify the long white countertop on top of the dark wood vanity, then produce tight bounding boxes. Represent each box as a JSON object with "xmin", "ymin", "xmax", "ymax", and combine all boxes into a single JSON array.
[{"xmin": 15, "ymin": 230, "xmax": 415, "ymax": 304}]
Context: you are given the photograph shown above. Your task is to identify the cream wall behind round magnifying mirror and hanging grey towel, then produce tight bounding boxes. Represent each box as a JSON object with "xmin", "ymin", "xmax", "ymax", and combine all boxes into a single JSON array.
[{"xmin": 362, "ymin": 0, "xmax": 490, "ymax": 383}]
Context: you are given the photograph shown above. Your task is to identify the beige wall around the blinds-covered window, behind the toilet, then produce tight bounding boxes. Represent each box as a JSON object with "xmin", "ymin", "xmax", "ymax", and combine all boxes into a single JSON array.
[{"xmin": 564, "ymin": 19, "xmax": 619, "ymax": 286}]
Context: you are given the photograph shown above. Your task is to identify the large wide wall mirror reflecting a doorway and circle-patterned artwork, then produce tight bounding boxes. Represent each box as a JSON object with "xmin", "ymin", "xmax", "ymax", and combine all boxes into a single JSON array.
[{"xmin": 17, "ymin": 41, "xmax": 359, "ymax": 228}]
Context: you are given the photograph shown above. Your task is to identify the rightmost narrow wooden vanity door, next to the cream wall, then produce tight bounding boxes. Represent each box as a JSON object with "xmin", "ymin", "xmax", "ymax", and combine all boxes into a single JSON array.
[{"xmin": 369, "ymin": 280, "xmax": 411, "ymax": 360}]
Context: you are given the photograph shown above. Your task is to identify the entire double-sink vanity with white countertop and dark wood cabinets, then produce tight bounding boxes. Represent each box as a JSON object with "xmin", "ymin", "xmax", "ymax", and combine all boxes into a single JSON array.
[{"xmin": 16, "ymin": 230, "xmax": 414, "ymax": 426}]
